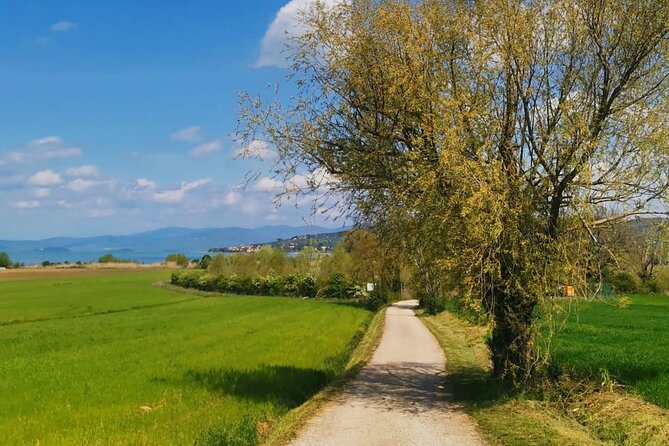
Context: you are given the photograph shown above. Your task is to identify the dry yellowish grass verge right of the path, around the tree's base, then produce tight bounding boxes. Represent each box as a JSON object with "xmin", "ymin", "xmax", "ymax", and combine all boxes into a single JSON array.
[{"xmin": 423, "ymin": 312, "xmax": 669, "ymax": 446}]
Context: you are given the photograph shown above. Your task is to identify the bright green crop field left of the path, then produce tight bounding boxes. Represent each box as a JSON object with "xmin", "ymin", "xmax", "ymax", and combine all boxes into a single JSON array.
[{"xmin": 0, "ymin": 271, "xmax": 370, "ymax": 445}]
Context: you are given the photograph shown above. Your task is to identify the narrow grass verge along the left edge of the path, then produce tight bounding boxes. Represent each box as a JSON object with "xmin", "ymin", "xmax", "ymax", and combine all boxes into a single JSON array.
[{"xmin": 262, "ymin": 309, "xmax": 386, "ymax": 446}]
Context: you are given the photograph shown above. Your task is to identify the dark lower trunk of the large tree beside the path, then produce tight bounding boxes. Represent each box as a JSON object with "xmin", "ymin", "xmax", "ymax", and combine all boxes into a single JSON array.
[{"xmin": 489, "ymin": 290, "xmax": 536, "ymax": 381}]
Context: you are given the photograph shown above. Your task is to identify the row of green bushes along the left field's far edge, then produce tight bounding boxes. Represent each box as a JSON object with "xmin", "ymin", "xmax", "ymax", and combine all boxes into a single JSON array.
[{"xmin": 170, "ymin": 229, "xmax": 402, "ymax": 311}]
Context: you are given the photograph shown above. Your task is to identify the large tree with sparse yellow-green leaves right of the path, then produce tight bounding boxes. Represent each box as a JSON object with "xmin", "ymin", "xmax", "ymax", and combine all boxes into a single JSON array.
[{"xmin": 240, "ymin": 0, "xmax": 669, "ymax": 379}]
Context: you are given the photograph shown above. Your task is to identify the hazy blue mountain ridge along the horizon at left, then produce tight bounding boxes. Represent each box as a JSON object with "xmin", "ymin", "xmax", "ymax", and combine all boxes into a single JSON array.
[{"xmin": 0, "ymin": 225, "xmax": 341, "ymax": 261}]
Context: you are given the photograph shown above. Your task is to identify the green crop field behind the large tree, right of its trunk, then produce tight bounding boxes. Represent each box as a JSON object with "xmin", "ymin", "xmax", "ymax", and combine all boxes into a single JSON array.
[{"xmin": 553, "ymin": 295, "xmax": 669, "ymax": 408}]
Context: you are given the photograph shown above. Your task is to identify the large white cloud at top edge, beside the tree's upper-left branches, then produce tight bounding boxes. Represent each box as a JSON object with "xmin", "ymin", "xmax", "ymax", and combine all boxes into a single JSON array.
[{"xmin": 255, "ymin": 0, "xmax": 347, "ymax": 68}]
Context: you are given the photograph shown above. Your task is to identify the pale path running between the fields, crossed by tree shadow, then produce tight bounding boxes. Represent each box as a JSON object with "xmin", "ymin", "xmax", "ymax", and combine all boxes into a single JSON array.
[{"xmin": 292, "ymin": 301, "xmax": 484, "ymax": 446}]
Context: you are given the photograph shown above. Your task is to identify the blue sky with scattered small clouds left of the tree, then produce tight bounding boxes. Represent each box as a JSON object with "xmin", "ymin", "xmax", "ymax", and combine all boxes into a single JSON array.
[{"xmin": 0, "ymin": 0, "xmax": 339, "ymax": 239}]
